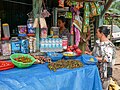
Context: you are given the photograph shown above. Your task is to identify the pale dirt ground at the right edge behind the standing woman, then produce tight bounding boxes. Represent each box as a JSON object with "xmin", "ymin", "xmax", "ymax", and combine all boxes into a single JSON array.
[{"xmin": 113, "ymin": 48, "xmax": 120, "ymax": 85}]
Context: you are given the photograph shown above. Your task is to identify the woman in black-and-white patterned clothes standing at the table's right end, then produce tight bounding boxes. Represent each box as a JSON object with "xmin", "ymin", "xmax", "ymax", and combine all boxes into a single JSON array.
[{"xmin": 85, "ymin": 26, "xmax": 116, "ymax": 90}]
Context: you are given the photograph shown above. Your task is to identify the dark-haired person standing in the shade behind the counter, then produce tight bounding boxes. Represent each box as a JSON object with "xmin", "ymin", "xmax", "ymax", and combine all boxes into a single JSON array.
[{"xmin": 58, "ymin": 16, "xmax": 70, "ymax": 44}]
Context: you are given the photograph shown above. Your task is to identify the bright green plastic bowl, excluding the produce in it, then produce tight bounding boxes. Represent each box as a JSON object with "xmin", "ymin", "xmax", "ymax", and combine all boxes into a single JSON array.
[{"xmin": 10, "ymin": 53, "xmax": 36, "ymax": 68}]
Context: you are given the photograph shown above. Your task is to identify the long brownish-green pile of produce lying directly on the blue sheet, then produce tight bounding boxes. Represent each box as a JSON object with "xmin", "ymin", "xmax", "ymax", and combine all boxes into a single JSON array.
[{"xmin": 48, "ymin": 60, "xmax": 83, "ymax": 71}]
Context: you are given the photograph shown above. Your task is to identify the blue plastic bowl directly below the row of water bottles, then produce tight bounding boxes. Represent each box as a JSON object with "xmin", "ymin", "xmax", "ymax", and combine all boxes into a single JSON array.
[{"xmin": 47, "ymin": 52, "xmax": 63, "ymax": 61}]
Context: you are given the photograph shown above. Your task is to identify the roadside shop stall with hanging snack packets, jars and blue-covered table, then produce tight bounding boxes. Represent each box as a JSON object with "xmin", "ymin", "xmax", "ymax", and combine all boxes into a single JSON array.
[{"xmin": 0, "ymin": 0, "xmax": 109, "ymax": 90}]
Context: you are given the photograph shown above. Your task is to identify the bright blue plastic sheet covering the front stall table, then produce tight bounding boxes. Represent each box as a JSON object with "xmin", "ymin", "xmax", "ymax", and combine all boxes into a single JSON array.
[{"xmin": 0, "ymin": 59, "xmax": 102, "ymax": 90}]
